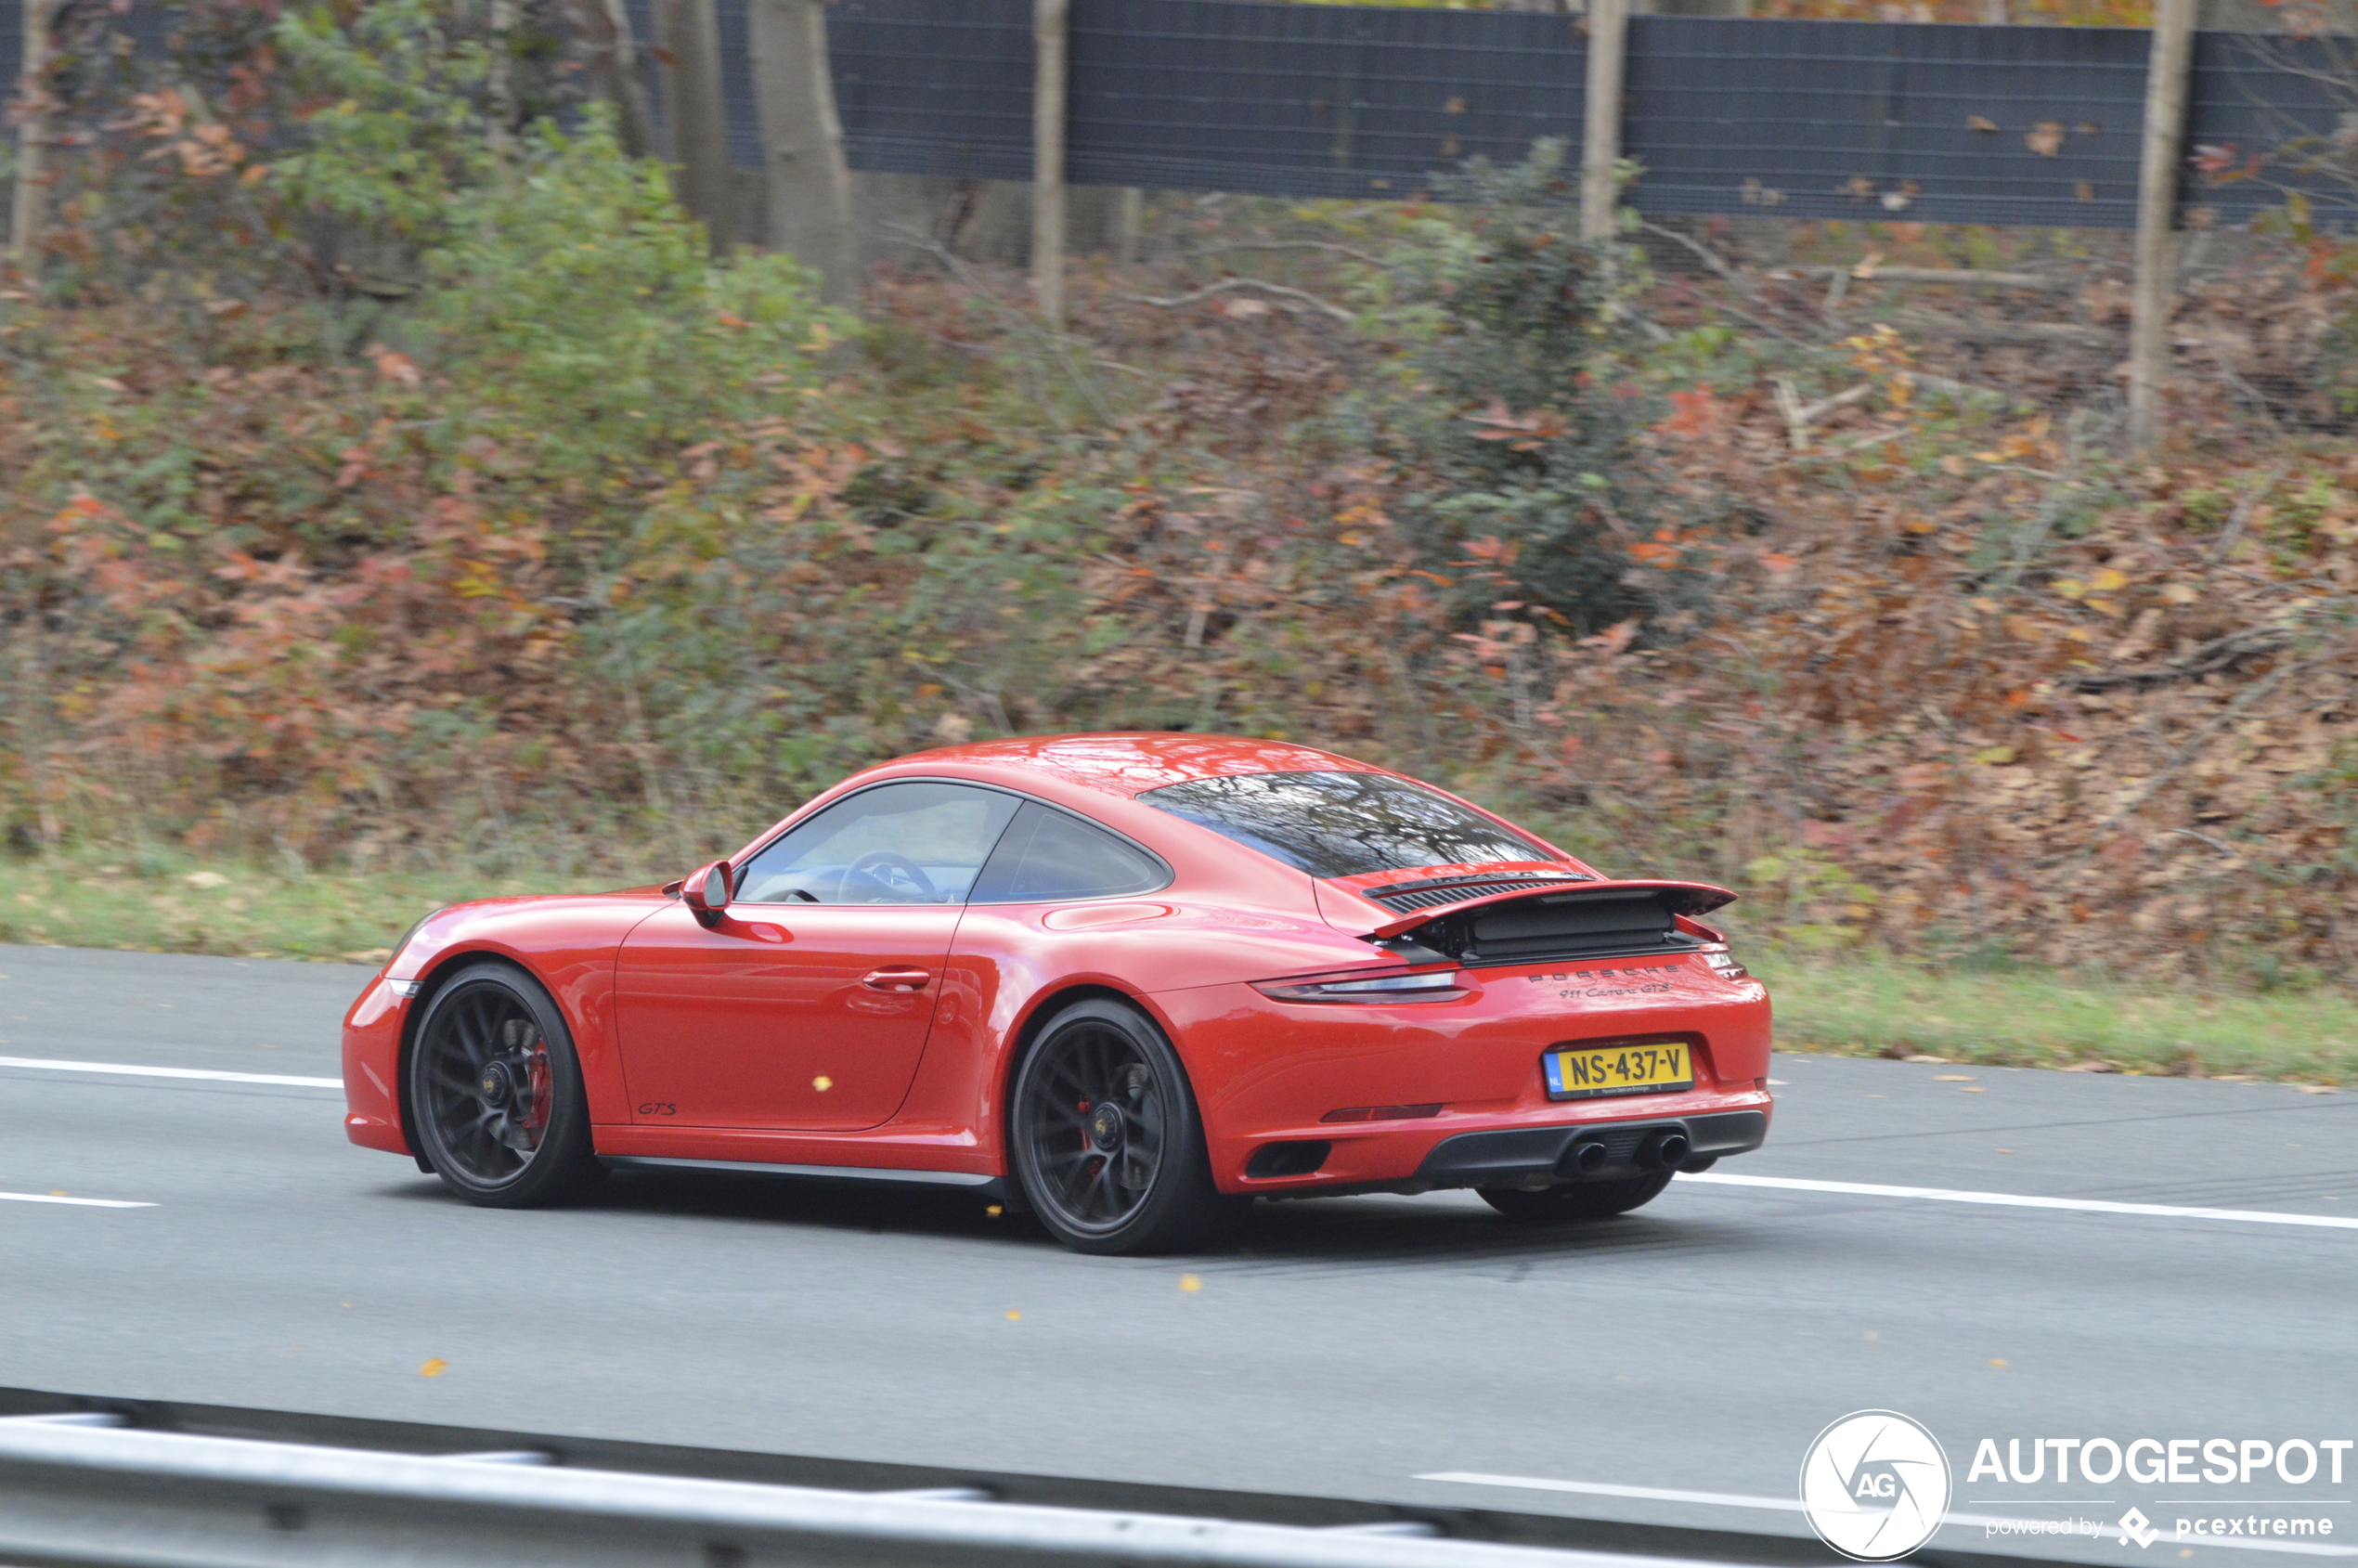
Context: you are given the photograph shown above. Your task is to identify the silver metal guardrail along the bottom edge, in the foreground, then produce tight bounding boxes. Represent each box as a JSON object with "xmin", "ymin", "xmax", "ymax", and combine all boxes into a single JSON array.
[{"xmin": 0, "ymin": 1412, "xmax": 1773, "ymax": 1568}]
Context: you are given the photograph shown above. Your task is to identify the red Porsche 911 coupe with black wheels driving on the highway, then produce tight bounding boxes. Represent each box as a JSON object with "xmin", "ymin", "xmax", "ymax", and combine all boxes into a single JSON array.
[{"xmin": 344, "ymin": 733, "xmax": 1771, "ymax": 1252}]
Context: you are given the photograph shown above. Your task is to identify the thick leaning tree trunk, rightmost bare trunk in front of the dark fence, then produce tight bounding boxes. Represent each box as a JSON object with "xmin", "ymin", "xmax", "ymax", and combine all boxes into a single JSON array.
[{"xmin": 747, "ymin": 0, "xmax": 859, "ymax": 305}]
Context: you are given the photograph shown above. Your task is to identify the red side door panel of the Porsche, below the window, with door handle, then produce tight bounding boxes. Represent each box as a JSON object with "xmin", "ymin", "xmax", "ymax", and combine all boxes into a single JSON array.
[{"xmin": 615, "ymin": 903, "xmax": 962, "ymax": 1132}]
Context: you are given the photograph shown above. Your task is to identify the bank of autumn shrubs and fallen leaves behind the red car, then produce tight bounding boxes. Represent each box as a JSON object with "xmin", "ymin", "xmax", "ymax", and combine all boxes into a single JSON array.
[{"xmin": 0, "ymin": 15, "xmax": 2358, "ymax": 981}]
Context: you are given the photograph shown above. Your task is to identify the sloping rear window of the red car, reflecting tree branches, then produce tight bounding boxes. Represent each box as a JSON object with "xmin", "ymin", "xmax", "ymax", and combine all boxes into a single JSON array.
[{"xmin": 1139, "ymin": 773, "xmax": 1563, "ymax": 877}]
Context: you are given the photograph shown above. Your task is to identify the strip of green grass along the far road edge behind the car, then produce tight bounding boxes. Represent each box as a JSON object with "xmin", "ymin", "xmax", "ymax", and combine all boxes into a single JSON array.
[{"xmin": 0, "ymin": 847, "xmax": 2358, "ymax": 1084}]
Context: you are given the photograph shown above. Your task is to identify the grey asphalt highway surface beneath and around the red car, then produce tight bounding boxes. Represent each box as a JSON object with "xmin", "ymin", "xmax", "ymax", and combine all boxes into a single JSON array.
[{"xmin": 0, "ymin": 948, "xmax": 2358, "ymax": 1565}]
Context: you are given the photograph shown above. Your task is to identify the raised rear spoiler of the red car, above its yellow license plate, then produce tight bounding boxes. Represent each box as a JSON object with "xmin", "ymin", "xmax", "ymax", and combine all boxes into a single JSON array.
[{"xmin": 1367, "ymin": 879, "xmax": 1735, "ymax": 960}]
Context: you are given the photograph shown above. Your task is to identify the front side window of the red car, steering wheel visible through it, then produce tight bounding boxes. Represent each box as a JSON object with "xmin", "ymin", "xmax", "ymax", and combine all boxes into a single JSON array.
[{"xmin": 735, "ymin": 783, "xmax": 1021, "ymax": 903}]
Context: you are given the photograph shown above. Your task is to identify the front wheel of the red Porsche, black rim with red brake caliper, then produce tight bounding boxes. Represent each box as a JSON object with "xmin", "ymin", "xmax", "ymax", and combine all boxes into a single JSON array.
[{"xmin": 408, "ymin": 965, "xmax": 606, "ymax": 1210}]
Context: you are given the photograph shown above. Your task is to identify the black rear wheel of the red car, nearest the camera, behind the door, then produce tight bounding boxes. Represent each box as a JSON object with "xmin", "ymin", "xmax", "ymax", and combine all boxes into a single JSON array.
[{"xmin": 1007, "ymin": 1000, "xmax": 1243, "ymax": 1254}]
